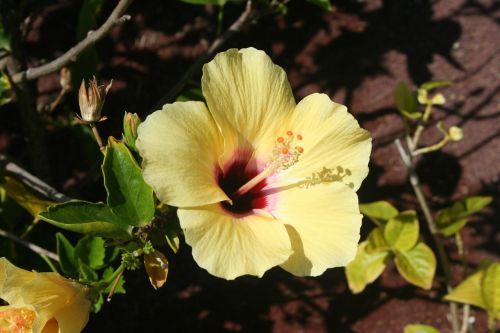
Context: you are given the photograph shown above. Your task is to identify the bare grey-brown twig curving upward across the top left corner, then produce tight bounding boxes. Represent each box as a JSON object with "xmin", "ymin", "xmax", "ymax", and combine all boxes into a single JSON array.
[{"xmin": 12, "ymin": 0, "xmax": 133, "ymax": 83}]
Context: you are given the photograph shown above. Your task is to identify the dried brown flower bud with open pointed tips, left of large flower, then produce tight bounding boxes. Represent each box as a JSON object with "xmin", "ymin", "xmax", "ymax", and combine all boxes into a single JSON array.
[{"xmin": 78, "ymin": 76, "xmax": 113, "ymax": 123}]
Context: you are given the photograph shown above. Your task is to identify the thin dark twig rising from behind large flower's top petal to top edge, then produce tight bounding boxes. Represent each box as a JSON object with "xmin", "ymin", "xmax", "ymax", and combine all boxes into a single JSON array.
[{"xmin": 154, "ymin": 0, "xmax": 286, "ymax": 110}]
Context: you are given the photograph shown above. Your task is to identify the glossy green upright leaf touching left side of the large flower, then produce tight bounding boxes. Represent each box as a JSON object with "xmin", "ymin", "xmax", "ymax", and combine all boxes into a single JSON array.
[{"xmin": 102, "ymin": 137, "xmax": 155, "ymax": 227}]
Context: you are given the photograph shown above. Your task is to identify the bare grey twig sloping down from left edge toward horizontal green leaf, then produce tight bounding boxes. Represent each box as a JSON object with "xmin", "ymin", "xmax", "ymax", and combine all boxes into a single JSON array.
[{"xmin": 0, "ymin": 154, "xmax": 71, "ymax": 202}]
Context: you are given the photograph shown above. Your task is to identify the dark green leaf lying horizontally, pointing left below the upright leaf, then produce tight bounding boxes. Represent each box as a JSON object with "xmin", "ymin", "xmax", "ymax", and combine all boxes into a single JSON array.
[{"xmin": 38, "ymin": 201, "xmax": 131, "ymax": 240}]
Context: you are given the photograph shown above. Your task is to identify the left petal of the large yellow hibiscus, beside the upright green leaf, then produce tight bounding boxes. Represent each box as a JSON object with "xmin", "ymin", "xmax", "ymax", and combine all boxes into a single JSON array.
[{"xmin": 136, "ymin": 102, "xmax": 228, "ymax": 207}]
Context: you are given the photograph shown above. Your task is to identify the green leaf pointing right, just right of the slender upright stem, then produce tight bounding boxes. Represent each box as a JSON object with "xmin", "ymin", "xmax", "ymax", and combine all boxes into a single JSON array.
[{"xmin": 436, "ymin": 196, "xmax": 492, "ymax": 236}]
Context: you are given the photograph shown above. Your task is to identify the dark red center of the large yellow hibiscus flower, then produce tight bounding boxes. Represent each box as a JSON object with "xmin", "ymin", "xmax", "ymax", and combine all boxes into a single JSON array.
[{"xmin": 217, "ymin": 151, "xmax": 268, "ymax": 217}]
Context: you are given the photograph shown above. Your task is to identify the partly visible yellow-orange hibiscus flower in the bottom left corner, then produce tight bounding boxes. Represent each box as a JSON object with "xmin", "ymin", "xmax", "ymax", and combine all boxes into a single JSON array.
[{"xmin": 0, "ymin": 258, "xmax": 90, "ymax": 333}]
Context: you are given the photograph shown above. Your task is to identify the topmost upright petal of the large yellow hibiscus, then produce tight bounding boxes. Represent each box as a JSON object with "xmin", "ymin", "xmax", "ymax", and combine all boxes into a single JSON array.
[{"xmin": 201, "ymin": 48, "xmax": 295, "ymax": 160}]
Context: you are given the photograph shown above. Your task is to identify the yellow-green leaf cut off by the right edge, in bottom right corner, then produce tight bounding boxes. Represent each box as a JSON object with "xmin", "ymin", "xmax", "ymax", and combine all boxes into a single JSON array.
[{"xmin": 481, "ymin": 263, "xmax": 500, "ymax": 319}]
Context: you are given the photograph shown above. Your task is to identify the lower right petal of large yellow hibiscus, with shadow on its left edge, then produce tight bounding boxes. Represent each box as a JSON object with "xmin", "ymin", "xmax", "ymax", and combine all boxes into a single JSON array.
[{"xmin": 272, "ymin": 182, "xmax": 362, "ymax": 276}]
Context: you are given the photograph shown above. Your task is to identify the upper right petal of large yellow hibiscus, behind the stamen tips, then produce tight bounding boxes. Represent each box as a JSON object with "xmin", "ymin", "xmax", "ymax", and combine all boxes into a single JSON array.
[{"xmin": 279, "ymin": 94, "xmax": 371, "ymax": 190}]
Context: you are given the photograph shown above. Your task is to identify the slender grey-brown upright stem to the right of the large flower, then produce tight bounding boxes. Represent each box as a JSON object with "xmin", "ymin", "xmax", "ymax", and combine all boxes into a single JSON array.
[{"xmin": 395, "ymin": 139, "xmax": 458, "ymax": 332}]
